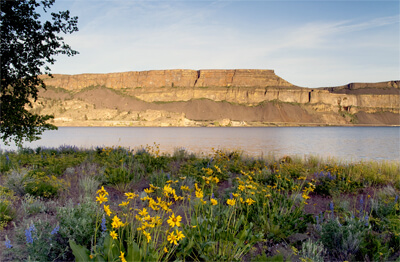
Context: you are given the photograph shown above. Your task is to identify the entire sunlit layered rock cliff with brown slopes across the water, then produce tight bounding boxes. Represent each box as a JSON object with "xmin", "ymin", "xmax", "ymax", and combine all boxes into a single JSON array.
[{"xmin": 34, "ymin": 69, "xmax": 400, "ymax": 126}]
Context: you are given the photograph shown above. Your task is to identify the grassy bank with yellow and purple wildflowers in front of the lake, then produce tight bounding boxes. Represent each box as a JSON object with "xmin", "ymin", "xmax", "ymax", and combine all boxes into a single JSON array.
[{"xmin": 0, "ymin": 145, "xmax": 400, "ymax": 261}]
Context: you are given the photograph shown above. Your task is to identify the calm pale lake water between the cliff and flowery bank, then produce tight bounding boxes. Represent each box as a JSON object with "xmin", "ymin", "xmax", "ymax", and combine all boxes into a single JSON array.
[{"xmin": 0, "ymin": 127, "xmax": 400, "ymax": 161}]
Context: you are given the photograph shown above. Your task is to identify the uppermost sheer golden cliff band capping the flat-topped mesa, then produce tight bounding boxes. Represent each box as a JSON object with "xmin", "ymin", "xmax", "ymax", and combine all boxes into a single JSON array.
[{"xmin": 42, "ymin": 69, "xmax": 294, "ymax": 90}]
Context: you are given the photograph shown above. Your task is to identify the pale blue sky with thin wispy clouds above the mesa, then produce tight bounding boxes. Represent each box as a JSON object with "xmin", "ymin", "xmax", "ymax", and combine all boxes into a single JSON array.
[{"xmin": 45, "ymin": 0, "xmax": 400, "ymax": 88}]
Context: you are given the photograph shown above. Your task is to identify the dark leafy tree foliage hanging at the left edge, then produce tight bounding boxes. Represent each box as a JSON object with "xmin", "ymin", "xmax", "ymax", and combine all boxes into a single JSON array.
[{"xmin": 0, "ymin": 0, "xmax": 78, "ymax": 145}]
